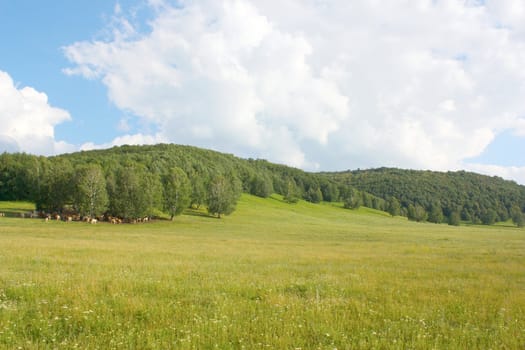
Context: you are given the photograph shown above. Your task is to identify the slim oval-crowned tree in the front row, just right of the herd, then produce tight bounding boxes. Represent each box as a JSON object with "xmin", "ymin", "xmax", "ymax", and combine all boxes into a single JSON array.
[{"xmin": 163, "ymin": 167, "xmax": 191, "ymax": 220}]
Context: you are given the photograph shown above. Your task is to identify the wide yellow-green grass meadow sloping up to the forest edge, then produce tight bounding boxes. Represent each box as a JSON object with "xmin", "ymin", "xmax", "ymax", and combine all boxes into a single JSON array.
[{"xmin": 0, "ymin": 195, "xmax": 525, "ymax": 349}]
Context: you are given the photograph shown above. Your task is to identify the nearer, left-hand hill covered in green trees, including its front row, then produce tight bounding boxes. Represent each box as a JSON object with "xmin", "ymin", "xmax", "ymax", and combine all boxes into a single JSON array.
[{"xmin": 0, "ymin": 144, "xmax": 340, "ymax": 218}]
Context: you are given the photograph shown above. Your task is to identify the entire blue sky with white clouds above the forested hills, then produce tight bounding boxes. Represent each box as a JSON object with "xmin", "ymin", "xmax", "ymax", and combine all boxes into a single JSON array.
[{"xmin": 0, "ymin": 0, "xmax": 525, "ymax": 184}]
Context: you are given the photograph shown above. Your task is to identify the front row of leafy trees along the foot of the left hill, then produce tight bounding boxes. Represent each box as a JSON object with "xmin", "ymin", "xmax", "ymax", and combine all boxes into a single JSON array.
[{"xmin": 0, "ymin": 150, "xmax": 242, "ymax": 220}]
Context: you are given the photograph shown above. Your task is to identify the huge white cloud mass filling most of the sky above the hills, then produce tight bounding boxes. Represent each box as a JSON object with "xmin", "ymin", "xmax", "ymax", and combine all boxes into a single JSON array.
[{"xmin": 64, "ymin": 0, "xmax": 525, "ymax": 183}]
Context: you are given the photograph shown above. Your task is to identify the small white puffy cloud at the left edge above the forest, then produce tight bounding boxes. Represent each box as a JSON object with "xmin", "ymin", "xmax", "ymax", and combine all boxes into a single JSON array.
[{"xmin": 0, "ymin": 71, "xmax": 73, "ymax": 155}]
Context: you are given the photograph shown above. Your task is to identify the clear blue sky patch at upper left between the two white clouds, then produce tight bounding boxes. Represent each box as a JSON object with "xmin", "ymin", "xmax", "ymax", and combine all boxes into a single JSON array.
[{"xmin": 0, "ymin": 0, "xmax": 130, "ymax": 143}]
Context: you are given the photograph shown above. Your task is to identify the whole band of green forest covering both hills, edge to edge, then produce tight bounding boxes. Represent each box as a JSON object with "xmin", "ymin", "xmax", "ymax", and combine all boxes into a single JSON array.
[{"xmin": 0, "ymin": 144, "xmax": 525, "ymax": 227}]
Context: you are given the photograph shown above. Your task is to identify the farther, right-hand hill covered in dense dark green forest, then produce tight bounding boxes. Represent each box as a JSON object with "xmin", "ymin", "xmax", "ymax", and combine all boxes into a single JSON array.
[{"xmin": 324, "ymin": 168, "xmax": 525, "ymax": 224}]
